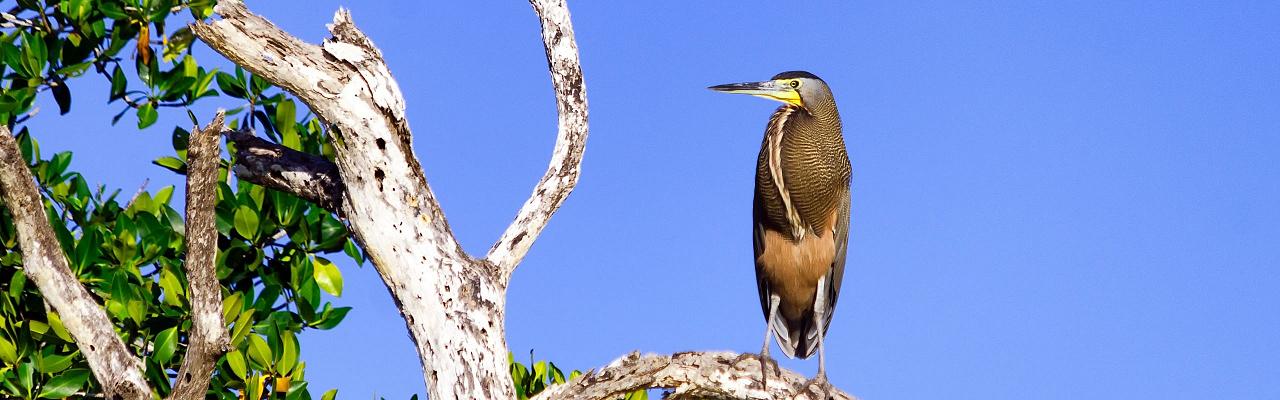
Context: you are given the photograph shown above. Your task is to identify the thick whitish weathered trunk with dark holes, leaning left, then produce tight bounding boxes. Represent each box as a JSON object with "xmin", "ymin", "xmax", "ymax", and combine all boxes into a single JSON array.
[{"xmin": 192, "ymin": 0, "xmax": 515, "ymax": 399}]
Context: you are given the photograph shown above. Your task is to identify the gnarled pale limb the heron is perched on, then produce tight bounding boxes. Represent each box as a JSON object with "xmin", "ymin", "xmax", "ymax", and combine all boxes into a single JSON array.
[{"xmin": 532, "ymin": 353, "xmax": 856, "ymax": 400}]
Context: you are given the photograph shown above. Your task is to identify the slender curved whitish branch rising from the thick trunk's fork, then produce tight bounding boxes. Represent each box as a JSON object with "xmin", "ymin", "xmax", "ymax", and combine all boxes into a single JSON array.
[{"xmin": 485, "ymin": 0, "xmax": 588, "ymax": 279}]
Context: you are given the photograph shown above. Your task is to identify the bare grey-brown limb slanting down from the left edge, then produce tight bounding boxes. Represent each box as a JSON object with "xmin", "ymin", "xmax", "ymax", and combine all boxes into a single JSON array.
[{"xmin": 0, "ymin": 124, "xmax": 151, "ymax": 400}]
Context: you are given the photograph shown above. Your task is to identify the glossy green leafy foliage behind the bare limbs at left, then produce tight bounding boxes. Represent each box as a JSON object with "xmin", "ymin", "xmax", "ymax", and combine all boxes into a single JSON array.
[{"xmin": 0, "ymin": 0, "xmax": 364, "ymax": 400}]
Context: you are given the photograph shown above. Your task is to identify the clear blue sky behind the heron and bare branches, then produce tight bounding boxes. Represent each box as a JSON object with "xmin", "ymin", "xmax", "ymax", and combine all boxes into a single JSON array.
[{"xmin": 22, "ymin": 0, "xmax": 1280, "ymax": 399}]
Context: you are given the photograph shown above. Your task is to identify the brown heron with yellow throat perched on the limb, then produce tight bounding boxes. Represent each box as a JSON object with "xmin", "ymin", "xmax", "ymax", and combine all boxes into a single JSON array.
[{"xmin": 710, "ymin": 71, "xmax": 850, "ymax": 383}]
